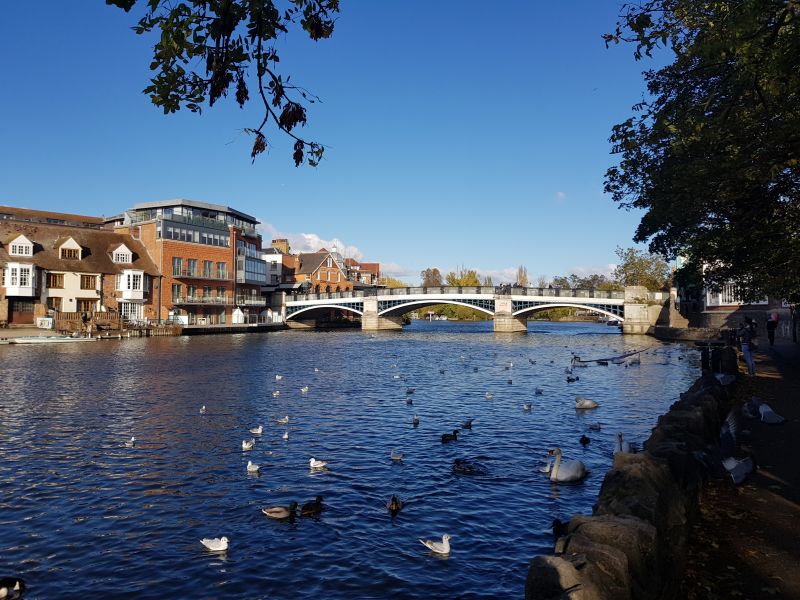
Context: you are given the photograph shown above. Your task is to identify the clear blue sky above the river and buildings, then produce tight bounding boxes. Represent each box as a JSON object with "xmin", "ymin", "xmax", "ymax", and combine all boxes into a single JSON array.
[{"xmin": 0, "ymin": 0, "xmax": 664, "ymax": 283}]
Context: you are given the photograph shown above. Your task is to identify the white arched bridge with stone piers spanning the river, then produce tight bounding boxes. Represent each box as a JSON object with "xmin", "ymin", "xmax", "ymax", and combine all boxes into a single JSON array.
[{"xmin": 284, "ymin": 286, "xmax": 649, "ymax": 333}]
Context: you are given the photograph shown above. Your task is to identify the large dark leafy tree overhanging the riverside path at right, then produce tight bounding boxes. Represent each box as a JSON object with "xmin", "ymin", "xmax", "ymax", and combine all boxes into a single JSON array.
[{"xmin": 604, "ymin": 0, "xmax": 800, "ymax": 300}]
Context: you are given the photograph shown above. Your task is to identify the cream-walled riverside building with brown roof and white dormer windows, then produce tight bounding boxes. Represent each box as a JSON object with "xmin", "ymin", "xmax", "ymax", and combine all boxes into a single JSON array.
[{"xmin": 0, "ymin": 206, "xmax": 159, "ymax": 324}]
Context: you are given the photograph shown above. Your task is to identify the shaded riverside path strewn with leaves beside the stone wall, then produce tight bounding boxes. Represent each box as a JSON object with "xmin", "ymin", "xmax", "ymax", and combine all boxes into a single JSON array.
[{"xmin": 686, "ymin": 337, "xmax": 800, "ymax": 600}]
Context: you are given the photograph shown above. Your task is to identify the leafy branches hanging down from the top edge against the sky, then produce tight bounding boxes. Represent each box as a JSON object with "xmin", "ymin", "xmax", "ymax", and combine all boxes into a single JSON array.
[{"xmin": 106, "ymin": 0, "xmax": 339, "ymax": 166}]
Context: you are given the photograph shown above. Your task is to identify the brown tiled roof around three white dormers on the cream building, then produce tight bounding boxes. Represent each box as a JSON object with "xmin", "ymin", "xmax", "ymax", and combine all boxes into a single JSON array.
[{"xmin": 0, "ymin": 220, "xmax": 159, "ymax": 275}]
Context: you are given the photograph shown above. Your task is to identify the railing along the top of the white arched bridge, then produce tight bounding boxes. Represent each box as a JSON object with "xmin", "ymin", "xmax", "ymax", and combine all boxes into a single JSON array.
[{"xmin": 286, "ymin": 285, "xmax": 625, "ymax": 302}]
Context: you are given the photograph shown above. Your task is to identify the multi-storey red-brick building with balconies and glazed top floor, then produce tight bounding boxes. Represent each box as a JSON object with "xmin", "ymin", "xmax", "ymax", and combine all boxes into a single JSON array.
[{"xmin": 106, "ymin": 199, "xmax": 267, "ymax": 325}]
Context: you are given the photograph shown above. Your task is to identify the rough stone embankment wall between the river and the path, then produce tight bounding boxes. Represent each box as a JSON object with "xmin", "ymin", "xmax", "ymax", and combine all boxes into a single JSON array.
[{"xmin": 525, "ymin": 348, "xmax": 738, "ymax": 600}]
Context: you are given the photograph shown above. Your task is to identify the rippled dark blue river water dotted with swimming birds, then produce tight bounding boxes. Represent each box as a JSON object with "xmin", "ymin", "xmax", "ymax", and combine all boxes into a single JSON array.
[{"xmin": 0, "ymin": 321, "xmax": 699, "ymax": 599}]
